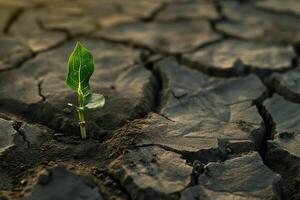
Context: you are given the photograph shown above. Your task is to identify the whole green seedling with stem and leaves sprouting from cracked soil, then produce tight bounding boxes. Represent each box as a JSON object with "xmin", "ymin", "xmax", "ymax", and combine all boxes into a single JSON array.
[{"xmin": 66, "ymin": 42, "xmax": 105, "ymax": 139}]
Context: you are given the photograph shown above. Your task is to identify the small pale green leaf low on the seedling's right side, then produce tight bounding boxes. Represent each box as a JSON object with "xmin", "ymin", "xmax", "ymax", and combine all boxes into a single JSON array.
[{"xmin": 84, "ymin": 93, "xmax": 105, "ymax": 112}]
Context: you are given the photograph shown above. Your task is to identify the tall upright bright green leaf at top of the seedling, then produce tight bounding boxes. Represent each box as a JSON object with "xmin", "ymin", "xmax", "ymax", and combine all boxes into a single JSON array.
[{"xmin": 66, "ymin": 42, "xmax": 94, "ymax": 96}]
